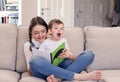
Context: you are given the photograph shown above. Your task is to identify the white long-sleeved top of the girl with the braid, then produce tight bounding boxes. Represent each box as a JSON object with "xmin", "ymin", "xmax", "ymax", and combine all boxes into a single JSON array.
[{"xmin": 24, "ymin": 39, "xmax": 41, "ymax": 68}]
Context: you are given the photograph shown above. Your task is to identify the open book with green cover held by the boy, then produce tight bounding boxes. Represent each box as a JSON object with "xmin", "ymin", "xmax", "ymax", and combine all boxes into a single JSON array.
[{"xmin": 33, "ymin": 42, "xmax": 65, "ymax": 66}]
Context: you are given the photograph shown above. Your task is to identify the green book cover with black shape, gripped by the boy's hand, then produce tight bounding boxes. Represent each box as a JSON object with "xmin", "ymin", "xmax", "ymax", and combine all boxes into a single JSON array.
[{"xmin": 51, "ymin": 42, "xmax": 65, "ymax": 66}]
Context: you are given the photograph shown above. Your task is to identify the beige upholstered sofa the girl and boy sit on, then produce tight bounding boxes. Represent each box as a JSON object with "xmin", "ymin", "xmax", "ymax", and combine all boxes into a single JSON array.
[{"xmin": 0, "ymin": 24, "xmax": 120, "ymax": 82}]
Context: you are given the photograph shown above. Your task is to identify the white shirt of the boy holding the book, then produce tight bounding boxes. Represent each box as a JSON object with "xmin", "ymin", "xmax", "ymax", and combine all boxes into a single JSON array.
[{"xmin": 39, "ymin": 38, "xmax": 69, "ymax": 52}]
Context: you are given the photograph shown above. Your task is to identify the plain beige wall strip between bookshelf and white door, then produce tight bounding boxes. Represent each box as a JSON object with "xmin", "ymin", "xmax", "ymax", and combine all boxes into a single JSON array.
[{"xmin": 20, "ymin": 0, "xmax": 37, "ymax": 25}]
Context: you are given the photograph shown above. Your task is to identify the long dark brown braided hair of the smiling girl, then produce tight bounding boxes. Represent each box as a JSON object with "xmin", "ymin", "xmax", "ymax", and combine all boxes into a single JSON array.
[{"xmin": 29, "ymin": 16, "xmax": 48, "ymax": 51}]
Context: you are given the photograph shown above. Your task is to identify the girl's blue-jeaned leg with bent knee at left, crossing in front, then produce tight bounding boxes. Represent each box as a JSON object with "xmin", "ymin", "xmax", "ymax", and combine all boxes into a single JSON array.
[{"xmin": 29, "ymin": 56, "xmax": 74, "ymax": 80}]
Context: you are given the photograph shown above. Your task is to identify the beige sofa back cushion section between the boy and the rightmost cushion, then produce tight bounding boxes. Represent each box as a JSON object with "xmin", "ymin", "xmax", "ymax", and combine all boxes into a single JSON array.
[{"xmin": 64, "ymin": 27, "xmax": 84, "ymax": 56}]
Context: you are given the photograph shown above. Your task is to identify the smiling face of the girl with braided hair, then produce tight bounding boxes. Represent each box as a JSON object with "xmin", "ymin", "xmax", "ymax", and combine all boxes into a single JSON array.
[{"xmin": 32, "ymin": 25, "xmax": 47, "ymax": 42}]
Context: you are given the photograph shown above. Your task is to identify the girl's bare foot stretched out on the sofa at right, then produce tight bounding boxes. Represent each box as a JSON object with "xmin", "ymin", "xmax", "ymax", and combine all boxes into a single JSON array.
[{"xmin": 74, "ymin": 71, "xmax": 102, "ymax": 81}]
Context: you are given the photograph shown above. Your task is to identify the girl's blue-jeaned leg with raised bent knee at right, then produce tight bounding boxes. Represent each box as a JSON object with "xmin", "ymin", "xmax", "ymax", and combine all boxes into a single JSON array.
[{"xmin": 66, "ymin": 50, "xmax": 94, "ymax": 73}]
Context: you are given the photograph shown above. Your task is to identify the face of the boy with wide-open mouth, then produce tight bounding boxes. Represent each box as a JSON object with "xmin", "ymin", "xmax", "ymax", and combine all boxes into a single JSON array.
[{"xmin": 49, "ymin": 24, "xmax": 64, "ymax": 41}]
